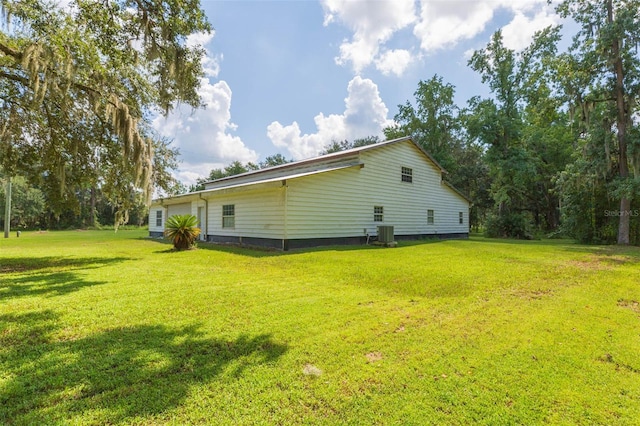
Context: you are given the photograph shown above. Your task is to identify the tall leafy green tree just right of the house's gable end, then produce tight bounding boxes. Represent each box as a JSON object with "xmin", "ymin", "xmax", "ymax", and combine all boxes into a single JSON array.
[{"xmin": 467, "ymin": 28, "xmax": 566, "ymax": 238}]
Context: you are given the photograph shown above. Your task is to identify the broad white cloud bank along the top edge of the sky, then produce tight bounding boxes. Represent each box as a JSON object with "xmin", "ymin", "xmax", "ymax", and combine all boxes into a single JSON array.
[{"xmin": 322, "ymin": 0, "xmax": 559, "ymax": 76}]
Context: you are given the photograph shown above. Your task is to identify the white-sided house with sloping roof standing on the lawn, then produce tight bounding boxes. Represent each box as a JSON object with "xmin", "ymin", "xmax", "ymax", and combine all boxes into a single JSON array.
[{"xmin": 149, "ymin": 137, "xmax": 470, "ymax": 250}]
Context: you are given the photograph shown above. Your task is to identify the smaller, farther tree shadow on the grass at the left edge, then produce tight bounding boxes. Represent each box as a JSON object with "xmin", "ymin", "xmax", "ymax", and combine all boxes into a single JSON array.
[{"xmin": 0, "ymin": 257, "xmax": 130, "ymax": 300}]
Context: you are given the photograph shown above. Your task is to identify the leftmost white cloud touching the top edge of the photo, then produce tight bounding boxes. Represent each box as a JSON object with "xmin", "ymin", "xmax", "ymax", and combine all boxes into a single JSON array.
[{"xmin": 322, "ymin": 0, "xmax": 416, "ymax": 73}]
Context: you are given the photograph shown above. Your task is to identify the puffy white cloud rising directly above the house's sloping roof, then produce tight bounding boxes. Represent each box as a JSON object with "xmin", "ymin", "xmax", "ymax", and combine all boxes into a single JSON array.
[{"xmin": 267, "ymin": 76, "xmax": 392, "ymax": 160}]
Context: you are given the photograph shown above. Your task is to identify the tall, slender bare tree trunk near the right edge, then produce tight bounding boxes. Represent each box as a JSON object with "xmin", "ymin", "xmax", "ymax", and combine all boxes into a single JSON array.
[{"xmin": 607, "ymin": 0, "xmax": 631, "ymax": 245}]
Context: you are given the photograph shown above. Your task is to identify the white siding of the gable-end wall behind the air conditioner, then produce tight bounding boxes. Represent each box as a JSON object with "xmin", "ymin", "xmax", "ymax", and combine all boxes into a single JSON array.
[{"xmin": 287, "ymin": 141, "xmax": 469, "ymax": 239}]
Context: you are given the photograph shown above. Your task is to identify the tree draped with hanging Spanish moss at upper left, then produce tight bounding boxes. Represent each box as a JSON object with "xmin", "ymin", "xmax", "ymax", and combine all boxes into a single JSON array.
[{"xmin": 0, "ymin": 0, "xmax": 211, "ymax": 230}]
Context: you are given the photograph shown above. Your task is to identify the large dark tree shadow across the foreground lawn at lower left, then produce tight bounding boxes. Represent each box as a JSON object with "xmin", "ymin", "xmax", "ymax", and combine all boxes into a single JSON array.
[{"xmin": 0, "ymin": 311, "xmax": 287, "ymax": 424}]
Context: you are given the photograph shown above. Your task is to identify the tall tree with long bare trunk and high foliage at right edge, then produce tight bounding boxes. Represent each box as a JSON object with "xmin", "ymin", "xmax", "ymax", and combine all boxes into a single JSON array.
[{"xmin": 558, "ymin": 0, "xmax": 640, "ymax": 244}]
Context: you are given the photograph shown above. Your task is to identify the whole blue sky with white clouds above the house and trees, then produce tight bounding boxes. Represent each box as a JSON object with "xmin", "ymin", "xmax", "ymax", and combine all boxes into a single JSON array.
[{"xmin": 154, "ymin": 0, "xmax": 560, "ymax": 185}]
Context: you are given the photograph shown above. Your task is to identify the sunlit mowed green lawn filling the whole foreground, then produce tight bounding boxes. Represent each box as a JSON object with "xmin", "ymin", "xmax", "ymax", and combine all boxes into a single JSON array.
[{"xmin": 0, "ymin": 231, "xmax": 640, "ymax": 425}]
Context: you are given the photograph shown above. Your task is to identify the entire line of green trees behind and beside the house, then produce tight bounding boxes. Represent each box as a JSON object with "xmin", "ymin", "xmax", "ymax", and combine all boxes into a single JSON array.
[{"xmin": 0, "ymin": 0, "xmax": 640, "ymax": 244}]
